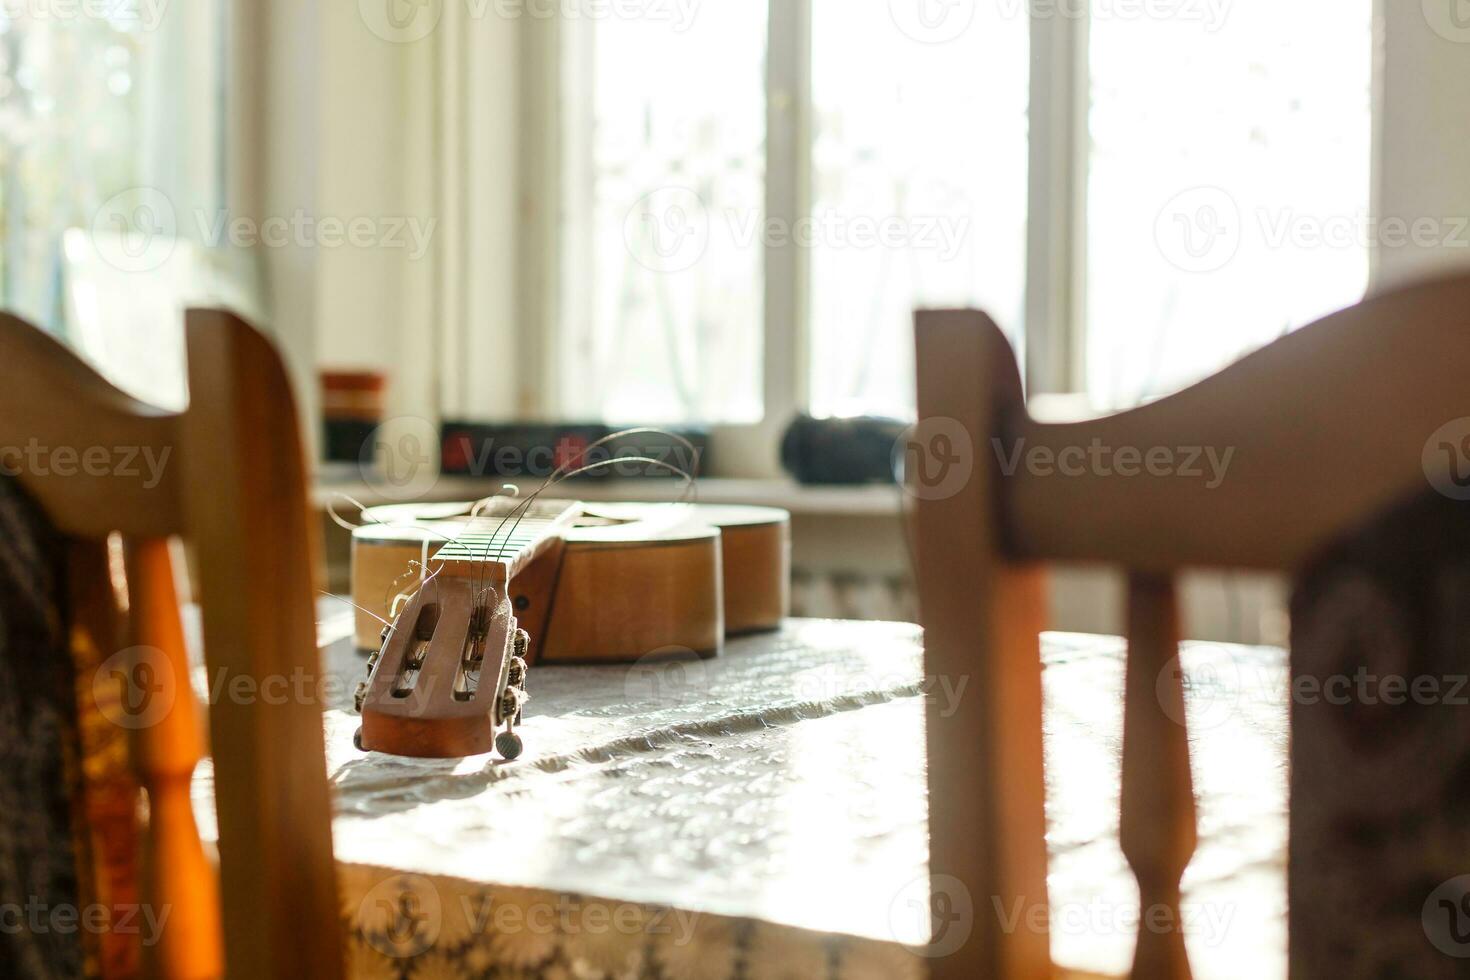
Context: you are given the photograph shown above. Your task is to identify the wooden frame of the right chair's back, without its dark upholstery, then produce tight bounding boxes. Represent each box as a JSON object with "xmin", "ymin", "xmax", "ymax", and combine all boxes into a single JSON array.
[{"xmin": 910, "ymin": 271, "xmax": 1470, "ymax": 980}]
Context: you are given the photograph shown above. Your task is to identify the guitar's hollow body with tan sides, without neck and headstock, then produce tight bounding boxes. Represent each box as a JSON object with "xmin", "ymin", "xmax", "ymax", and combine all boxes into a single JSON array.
[{"xmin": 353, "ymin": 504, "xmax": 791, "ymax": 664}]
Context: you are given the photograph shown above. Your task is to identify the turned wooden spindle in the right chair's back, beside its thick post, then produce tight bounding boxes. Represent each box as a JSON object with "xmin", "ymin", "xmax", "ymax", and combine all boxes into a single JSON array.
[{"xmin": 1119, "ymin": 573, "xmax": 1195, "ymax": 980}]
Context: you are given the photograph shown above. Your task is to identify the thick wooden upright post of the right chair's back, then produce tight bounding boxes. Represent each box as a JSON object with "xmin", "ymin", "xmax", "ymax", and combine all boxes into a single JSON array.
[{"xmin": 906, "ymin": 310, "xmax": 1053, "ymax": 980}]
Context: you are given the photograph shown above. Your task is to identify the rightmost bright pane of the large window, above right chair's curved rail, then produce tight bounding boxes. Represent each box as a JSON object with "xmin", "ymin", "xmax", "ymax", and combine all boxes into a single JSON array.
[{"xmin": 1086, "ymin": 0, "xmax": 1373, "ymax": 407}]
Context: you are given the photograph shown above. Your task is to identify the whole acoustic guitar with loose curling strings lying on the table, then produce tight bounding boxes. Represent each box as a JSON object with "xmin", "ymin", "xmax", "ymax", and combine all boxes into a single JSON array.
[{"xmin": 351, "ymin": 498, "xmax": 791, "ymax": 758}]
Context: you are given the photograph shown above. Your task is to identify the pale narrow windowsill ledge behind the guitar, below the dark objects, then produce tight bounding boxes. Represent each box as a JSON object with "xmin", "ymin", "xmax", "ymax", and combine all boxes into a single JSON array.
[{"xmin": 312, "ymin": 467, "xmax": 906, "ymax": 519}]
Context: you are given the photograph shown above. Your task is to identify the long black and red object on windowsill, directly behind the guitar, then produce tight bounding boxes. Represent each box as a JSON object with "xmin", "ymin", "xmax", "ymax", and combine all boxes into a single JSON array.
[{"xmin": 440, "ymin": 420, "xmax": 710, "ymax": 479}]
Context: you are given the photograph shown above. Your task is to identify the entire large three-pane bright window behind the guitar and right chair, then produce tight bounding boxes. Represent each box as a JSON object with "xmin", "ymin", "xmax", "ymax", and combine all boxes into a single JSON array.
[{"xmin": 543, "ymin": 0, "xmax": 1373, "ymax": 430}]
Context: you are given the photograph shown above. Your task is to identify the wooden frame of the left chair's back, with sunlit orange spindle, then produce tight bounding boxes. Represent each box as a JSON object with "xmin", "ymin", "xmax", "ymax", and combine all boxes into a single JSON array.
[{"xmin": 0, "ymin": 310, "xmax": 343, "ymax": 977}]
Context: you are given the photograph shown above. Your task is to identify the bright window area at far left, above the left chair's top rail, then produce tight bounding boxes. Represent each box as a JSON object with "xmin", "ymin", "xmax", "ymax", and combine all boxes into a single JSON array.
[{"xmin": 0, "ymin": 0, "xmax": 248, "ymax": 407}]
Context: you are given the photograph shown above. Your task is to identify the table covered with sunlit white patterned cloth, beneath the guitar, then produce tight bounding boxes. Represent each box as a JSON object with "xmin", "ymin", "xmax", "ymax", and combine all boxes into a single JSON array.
[{"xmin": 197, "ymin": 614, "xmax": 1286, "ymax": 980}]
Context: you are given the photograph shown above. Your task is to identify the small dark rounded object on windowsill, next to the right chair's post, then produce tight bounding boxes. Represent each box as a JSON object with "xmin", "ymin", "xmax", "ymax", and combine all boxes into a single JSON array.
[{"xmin": 781, "ymin": 416, "xmax": 908, "ymax": 485}]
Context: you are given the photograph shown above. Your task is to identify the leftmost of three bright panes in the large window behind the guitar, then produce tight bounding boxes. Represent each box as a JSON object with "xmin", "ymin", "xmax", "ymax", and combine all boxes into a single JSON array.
[{"xmin": 560, "ymin": 1, "xmax": 766, "ymax": 423}]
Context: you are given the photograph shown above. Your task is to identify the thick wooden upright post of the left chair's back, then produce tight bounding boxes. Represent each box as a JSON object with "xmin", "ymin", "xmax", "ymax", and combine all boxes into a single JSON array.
[{"xmin": 179, "ymin": 310, "xmax": 344, "ymax": 980}]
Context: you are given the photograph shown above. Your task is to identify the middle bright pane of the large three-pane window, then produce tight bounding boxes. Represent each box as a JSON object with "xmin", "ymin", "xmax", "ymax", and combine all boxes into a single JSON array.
[{"xmin": 809, "ymin": 0, "xmax": 1029, "ymax": 416}]
